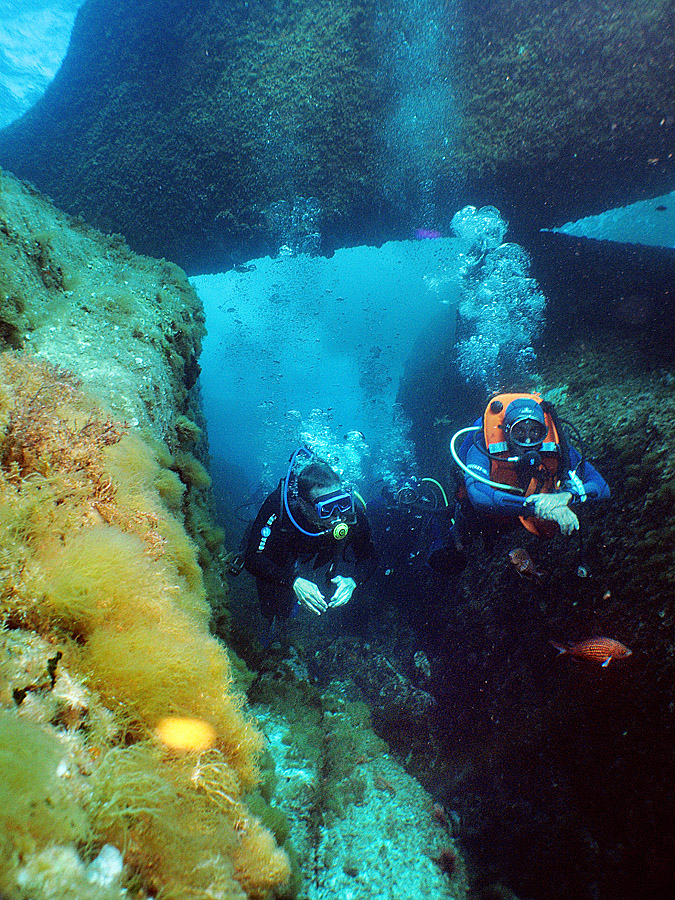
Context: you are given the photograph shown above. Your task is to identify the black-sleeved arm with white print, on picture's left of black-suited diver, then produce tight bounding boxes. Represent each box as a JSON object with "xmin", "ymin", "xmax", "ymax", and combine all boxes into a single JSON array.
[{"xmin": 244, "ymin": 491, "xmax": 295, "ymax": 587}]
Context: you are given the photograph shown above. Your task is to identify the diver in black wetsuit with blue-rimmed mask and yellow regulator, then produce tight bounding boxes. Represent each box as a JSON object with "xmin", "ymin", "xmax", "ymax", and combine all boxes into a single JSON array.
[{"xmin": 244, "ymin": 447, "xmax": 376, "ymax": 621}]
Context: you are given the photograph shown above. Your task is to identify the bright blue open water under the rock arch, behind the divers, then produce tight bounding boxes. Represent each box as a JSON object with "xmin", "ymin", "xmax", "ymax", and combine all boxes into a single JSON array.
[{"xmin": 192, "ymin": 239, "xmax": 459, "ymax": 502}]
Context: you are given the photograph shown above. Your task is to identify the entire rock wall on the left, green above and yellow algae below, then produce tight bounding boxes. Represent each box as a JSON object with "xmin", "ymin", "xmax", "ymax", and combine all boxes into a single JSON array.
[{"xmin": 0, "ymin": 175, "xmax": 290, "ymax": 900}]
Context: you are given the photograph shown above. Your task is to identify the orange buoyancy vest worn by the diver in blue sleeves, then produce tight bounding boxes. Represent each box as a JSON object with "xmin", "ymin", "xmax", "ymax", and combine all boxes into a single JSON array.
[{"xmin": 483, "ymin": 392, "xmax": 560, "ymax": 537}]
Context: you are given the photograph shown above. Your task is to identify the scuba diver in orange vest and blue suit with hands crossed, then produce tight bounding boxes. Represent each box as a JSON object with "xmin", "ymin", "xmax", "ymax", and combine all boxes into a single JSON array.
[{"xmin": 450, "ymin": 393, "xmax": 609, "ymax": 538}]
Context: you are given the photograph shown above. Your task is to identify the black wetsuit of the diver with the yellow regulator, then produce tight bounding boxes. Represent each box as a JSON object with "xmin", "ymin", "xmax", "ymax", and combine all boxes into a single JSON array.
[{"xmin": 244, "ymin": 484, "xmax": 376, "ymax": 619}]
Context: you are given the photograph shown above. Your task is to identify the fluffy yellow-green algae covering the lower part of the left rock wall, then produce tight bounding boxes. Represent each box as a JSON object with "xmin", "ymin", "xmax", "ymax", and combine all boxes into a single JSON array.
[{"xmin": 0, "ymin": 353, "xmax": 290, "ymax": 898}]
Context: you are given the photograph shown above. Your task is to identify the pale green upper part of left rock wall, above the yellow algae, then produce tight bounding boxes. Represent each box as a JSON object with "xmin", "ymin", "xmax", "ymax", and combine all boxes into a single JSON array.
[{"xmin": 0, "ymin": 172, "xmax": 205, "ymax": 438}]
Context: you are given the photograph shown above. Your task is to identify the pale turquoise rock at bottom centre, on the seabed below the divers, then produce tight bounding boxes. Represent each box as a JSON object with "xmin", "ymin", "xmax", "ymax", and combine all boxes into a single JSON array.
[{"xmin": 251, "ymin": 650, "xmax": 468, "ymax": 900}]
